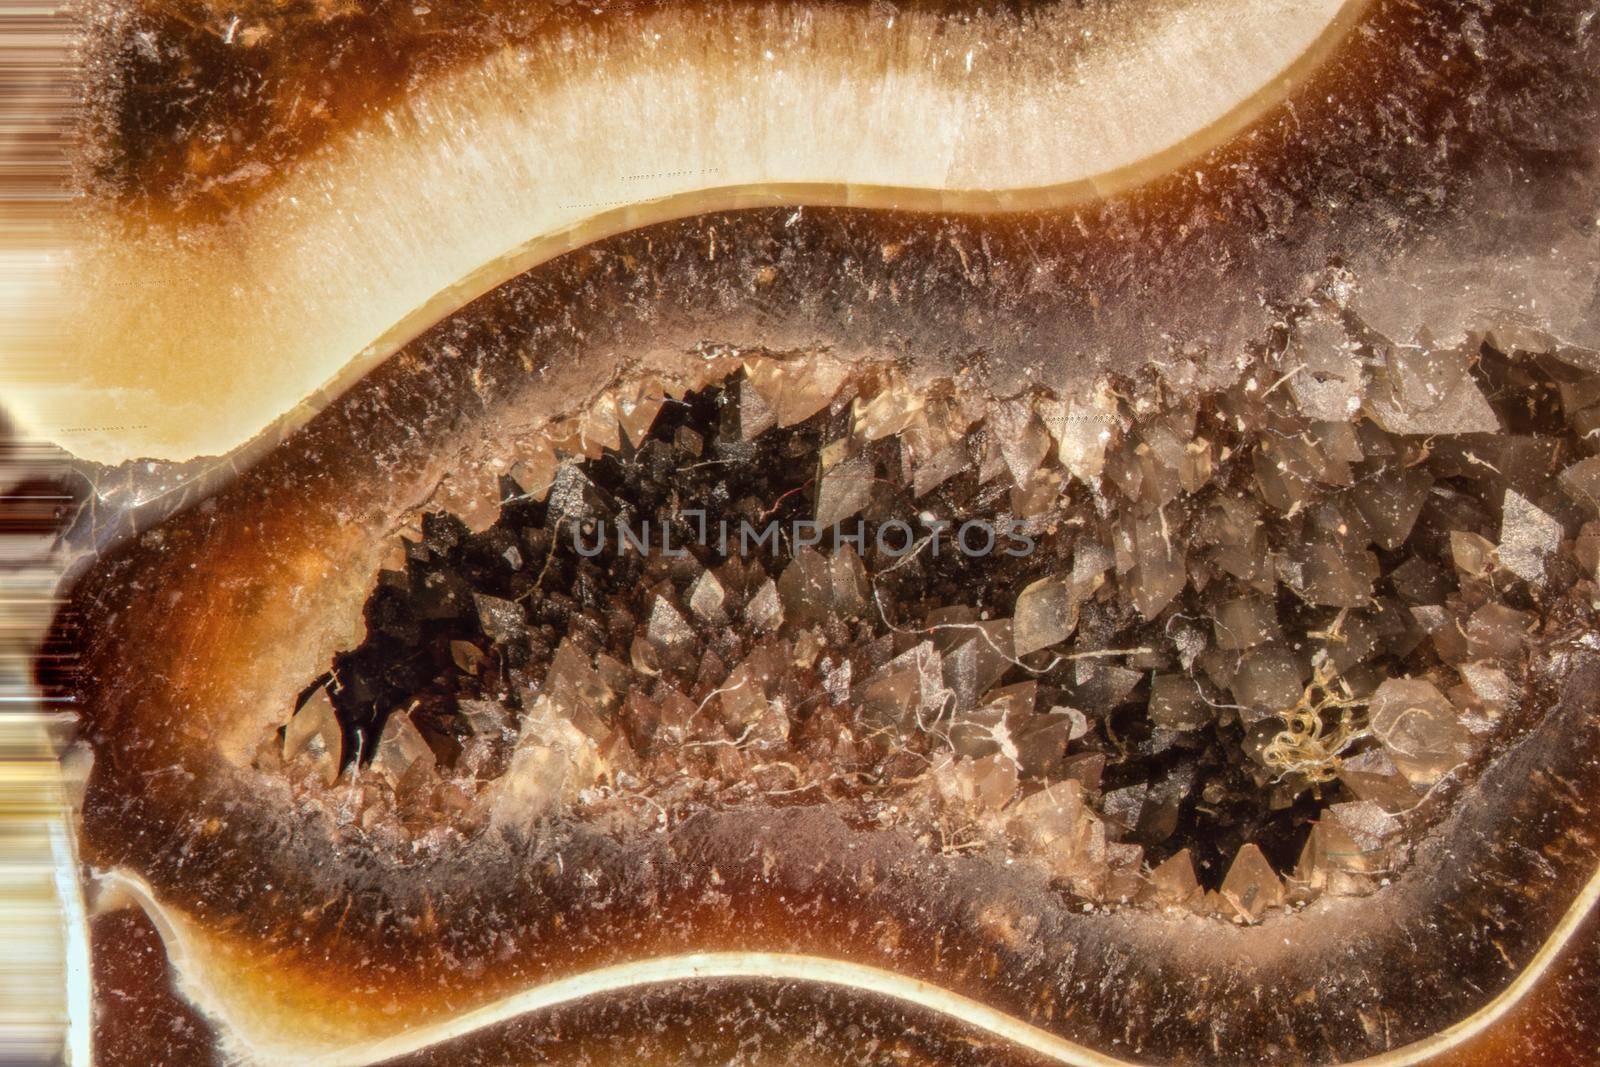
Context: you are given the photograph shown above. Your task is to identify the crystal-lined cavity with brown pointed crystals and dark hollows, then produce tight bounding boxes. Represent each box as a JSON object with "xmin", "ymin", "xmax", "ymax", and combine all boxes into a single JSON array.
[{"xmin": 259, "ymin": 329, "xmax": 1600, "ymax": 921}]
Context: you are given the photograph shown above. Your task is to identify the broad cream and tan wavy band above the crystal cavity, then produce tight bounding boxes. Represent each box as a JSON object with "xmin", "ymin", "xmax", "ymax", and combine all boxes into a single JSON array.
[{"xmin": 40, "ymin": 0, "xmax": 1365, "ymax": 462}]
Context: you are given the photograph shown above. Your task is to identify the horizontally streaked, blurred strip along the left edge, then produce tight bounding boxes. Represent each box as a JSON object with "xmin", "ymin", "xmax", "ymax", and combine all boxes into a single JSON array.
[{"xmin": 0, "ymin": 0, "xmax": 90, "ymax": 1067}]
